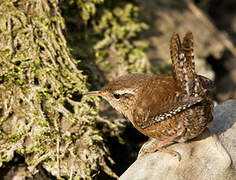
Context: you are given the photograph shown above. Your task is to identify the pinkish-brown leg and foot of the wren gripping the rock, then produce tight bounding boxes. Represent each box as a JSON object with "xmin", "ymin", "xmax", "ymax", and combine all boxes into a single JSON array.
[{"xmin": 142, "ymin": 128, "xmax": 186, "ymax": 161}]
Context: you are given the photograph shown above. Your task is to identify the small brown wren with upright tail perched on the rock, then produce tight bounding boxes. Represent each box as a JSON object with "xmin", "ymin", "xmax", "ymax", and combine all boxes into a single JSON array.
[{"xmin": 85, "ymin": 32, "xmax": 213, "ymax": 159}]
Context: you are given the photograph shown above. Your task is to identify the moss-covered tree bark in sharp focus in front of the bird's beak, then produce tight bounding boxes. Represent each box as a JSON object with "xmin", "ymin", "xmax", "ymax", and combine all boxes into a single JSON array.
[{"xmin": 0, "ymin": 0, "xmax": 120, "ymax": 179}]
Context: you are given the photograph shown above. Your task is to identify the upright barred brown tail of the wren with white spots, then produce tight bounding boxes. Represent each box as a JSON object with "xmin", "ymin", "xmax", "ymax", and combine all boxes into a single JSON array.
[{"xmin": 170, "ymin": 32, "xmax": 204, "ymax": 97}]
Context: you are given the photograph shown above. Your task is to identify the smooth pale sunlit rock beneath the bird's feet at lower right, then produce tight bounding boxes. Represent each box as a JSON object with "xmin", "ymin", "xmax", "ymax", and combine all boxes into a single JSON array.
[{"xmin": 120, "ymin": 100, "xmax": 236, "ymax": 180}]
